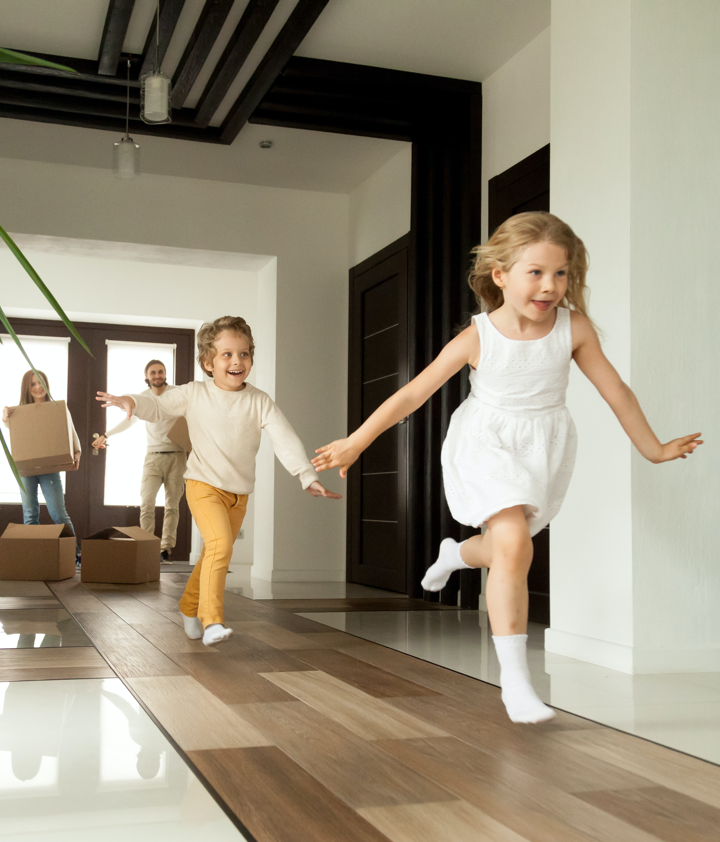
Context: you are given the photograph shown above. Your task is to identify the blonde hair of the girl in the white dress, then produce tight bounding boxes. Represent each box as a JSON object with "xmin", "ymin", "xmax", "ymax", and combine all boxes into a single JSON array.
[{"xmin": 468, "ymin": 211, "xmax": 588, "ymax": 316}]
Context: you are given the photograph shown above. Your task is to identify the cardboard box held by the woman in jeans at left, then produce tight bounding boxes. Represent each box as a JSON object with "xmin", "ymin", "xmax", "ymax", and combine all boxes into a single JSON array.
[{"xmin": 8, "ymin": 401, "xmax": 75, "ymax": 477}]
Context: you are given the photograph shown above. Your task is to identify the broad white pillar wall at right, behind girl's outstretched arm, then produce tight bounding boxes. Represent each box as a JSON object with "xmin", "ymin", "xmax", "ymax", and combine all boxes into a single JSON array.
[{"xmin": 546, "ymin": 0, "xmax": 720, "ymax": 672}]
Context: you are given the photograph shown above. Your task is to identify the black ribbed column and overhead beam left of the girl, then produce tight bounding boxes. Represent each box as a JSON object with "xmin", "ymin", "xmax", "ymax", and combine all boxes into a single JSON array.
[{"xmin": 250, "ymin": 56, "xmax": 482, "ymax": 608}]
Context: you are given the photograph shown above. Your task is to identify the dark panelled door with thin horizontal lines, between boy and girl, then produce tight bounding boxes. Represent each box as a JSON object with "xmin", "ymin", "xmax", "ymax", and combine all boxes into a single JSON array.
[{"xmin": 347, "ymin": 239, "xmax": 408, "ymax": 593}]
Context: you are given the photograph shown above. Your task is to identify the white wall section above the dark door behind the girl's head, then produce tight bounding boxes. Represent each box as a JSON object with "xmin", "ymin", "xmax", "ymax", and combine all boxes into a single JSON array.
[{"xmin": 481, "ymin": 28, "xmax": 550, "ymax": 242}]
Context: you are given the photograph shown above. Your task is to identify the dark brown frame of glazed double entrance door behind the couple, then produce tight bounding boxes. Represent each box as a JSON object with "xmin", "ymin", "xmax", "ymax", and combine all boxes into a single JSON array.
[{"xmin": 0, "ymin": 319, "xmax": 195, "ymax": 561}]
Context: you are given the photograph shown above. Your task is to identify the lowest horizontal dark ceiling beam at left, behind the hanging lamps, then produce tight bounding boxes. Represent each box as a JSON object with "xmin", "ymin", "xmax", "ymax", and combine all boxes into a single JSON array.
[{"xmin": 0, "ymin": 102, "xmax": 220, "ymax": 143}]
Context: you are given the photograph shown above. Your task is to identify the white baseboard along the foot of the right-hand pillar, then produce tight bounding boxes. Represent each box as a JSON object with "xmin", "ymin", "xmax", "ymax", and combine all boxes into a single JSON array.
[{"xmin": 545, "ymin": 629, "xmax": 720, "ymax": 675}]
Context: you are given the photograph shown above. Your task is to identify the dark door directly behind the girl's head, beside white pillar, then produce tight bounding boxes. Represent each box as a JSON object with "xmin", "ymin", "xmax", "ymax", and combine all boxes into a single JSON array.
[{"xmin": 488, "ymin": 144, "xmax": 550, "ymax": 625}]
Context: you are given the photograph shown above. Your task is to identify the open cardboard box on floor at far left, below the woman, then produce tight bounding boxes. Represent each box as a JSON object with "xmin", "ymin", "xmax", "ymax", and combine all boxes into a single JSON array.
[{"xmin": 0, "ymin": 523, "xmax": 75, "ymax": 582}]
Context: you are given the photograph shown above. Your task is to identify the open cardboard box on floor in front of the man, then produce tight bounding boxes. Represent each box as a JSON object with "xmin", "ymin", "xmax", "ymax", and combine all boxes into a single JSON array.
[{"xmin": 80, "ymin": 526, "xmax": 160, "ymax": 585}]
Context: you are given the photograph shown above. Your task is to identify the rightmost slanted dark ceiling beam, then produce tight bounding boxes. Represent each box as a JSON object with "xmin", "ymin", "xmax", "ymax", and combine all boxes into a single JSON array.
[{"xmin": 220, "ymin": 0, "xmax": 328, "ymax": 144}]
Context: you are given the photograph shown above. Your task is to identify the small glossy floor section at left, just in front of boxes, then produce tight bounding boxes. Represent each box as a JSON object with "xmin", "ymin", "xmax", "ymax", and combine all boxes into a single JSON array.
[{"xmin": 0, "ymin": 608, "xmax": 92, "ymax": 649}]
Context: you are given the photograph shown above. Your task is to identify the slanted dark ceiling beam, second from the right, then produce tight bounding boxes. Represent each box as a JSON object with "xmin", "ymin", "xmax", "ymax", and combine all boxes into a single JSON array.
[{"xmin": 197, "ymin": 0, "xmax": 279, "ymax": 128}]
